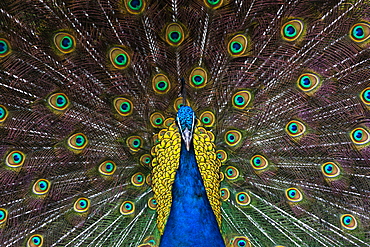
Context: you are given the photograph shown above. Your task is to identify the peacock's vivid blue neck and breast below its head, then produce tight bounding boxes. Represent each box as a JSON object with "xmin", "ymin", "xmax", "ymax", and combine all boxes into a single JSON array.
[{"xmin": 159, "ymin": 141, "xmax": 225, "ymax": 247}]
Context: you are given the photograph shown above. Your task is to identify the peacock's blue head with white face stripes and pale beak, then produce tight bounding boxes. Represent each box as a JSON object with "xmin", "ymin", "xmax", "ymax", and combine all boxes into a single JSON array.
[{"xmin": 176, "ymin": 106, "xmax": 195, "ymax": 151}]
